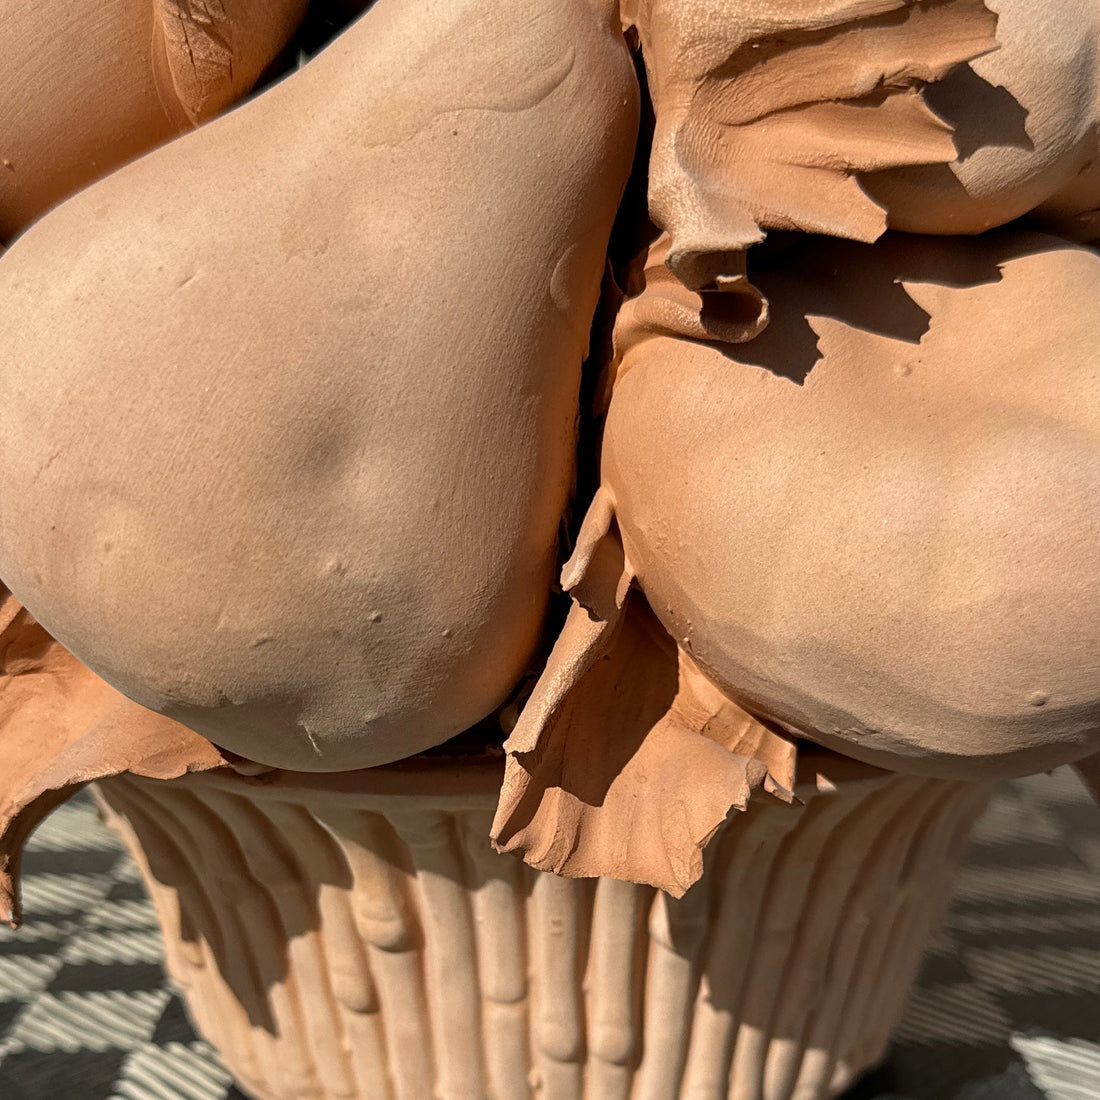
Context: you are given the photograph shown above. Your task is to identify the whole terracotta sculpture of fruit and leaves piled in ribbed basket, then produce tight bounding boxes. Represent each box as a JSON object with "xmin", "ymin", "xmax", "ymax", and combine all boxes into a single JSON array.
[{"xmin": 0, "ymin": 0, "xmax": 1100, "ymax": 1100}]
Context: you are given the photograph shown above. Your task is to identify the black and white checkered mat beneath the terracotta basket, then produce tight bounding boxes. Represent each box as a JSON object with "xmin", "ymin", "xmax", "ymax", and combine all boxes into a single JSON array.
[{"xmin": 0, "ymin": 769, "xmax": 1100, "ymax": 1100}]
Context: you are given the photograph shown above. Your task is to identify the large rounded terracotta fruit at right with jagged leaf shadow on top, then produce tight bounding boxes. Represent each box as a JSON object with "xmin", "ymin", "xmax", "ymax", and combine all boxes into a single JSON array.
[{"xmin": 603, "ymin": 234, "xmax": 1100, "ymax": 778}]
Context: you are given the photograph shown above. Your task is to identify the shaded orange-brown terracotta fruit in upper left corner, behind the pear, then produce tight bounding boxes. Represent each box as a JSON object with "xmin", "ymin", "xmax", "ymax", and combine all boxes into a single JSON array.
[{"xmin": 0, "ymin": 0, "xmax": 306, "ymax": 244}]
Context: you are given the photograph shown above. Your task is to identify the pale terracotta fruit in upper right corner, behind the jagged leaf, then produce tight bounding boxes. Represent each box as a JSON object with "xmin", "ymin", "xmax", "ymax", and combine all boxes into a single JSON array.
[{"xmin": 860, "ymin": 0, "xmax": 1100, "ymax": 241}]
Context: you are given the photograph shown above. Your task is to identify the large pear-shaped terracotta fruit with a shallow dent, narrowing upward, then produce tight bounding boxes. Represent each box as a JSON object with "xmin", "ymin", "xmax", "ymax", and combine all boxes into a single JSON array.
[{"xmin": 0, "ymin": 0, "xmax": 638, "ymax": 770}]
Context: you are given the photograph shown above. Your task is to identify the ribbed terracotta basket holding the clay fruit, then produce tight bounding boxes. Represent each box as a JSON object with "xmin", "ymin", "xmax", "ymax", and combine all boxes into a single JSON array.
[{"xmin": 92, "ymin": 755, "xmax": 989, "ymax": 1100}]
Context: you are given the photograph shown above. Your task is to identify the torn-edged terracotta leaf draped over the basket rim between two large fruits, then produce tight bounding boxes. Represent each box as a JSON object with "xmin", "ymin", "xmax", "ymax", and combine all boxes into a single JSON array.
[{"xmin": 492, "ymin": 498, "xmax": 794, "ymax": 898}]
